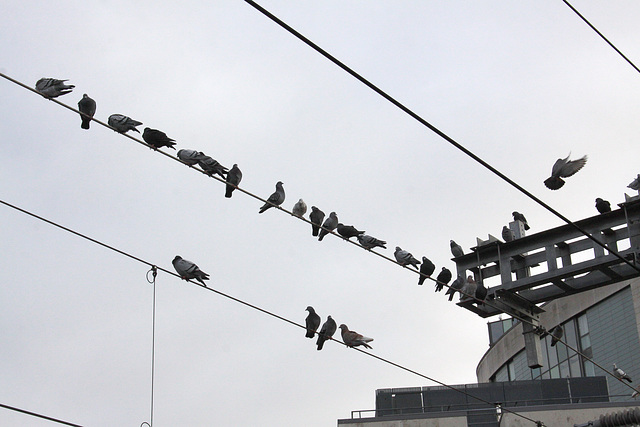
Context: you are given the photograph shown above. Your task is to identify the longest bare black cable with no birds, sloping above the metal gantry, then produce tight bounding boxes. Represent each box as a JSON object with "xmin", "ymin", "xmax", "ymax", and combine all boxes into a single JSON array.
[{"xmin": 244, "ymin": 0, "xmax": 640, "ymax": 272}]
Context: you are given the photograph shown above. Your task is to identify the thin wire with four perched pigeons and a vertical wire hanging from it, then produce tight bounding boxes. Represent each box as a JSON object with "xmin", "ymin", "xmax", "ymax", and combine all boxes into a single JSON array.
[{"xmin": 0, "ymin": 200, "xmax": 540, "ymax": 425}]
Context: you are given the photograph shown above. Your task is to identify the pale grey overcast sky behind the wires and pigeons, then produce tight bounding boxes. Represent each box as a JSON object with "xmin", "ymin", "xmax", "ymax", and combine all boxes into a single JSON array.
[{"xmin": 0, "ymin": 0, "xmax": 640, "ymax": 427}]
